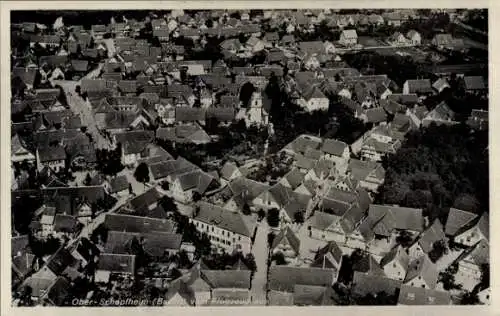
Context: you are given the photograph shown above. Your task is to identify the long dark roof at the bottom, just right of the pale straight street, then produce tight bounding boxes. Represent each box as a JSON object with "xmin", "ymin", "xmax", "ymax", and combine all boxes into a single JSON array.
[{"xmin": 268, "ymin": 265, "xmax": 334, "ymax": 293}]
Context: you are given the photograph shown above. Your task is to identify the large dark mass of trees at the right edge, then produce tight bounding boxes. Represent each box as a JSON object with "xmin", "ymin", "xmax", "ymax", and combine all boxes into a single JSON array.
[{"xmin": 376, "ymin": 125, "xmax": 489, "ymax": 223}]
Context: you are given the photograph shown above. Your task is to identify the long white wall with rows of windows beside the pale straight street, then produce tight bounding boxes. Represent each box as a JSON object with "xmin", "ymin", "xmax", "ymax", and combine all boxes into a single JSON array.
[{"xmin": 190, "ymin": 219, "xmax": 252, "ymax": 253}]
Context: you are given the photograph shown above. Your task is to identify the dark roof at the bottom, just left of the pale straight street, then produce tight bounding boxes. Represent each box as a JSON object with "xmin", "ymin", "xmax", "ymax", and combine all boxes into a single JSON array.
[{"xmin": 201, "ymin": 270, "xmax": 252, "ymax": 289}]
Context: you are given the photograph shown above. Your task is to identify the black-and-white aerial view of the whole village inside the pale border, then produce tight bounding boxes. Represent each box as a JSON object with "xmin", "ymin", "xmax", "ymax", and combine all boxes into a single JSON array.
[{"xmin": 9, "ymin": 9, "xmax": 491, "ymax": 307}]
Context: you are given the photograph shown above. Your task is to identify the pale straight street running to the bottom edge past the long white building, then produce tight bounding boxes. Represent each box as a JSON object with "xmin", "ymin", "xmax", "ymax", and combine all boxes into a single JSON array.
[{"xmin": 250, "ymin": 220, "xmax": 269, "ymax": 305}]
